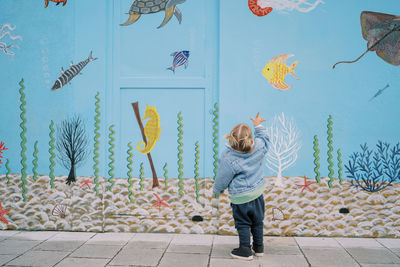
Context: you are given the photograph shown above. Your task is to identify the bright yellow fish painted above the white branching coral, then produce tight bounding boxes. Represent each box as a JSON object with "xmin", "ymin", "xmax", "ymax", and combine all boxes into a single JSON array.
[{"xmin": 262, "ymin": 54, "xmax": 298, "ymax": 90}]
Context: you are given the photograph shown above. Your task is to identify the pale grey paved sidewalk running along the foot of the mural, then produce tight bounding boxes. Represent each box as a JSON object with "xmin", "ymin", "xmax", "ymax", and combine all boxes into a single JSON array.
[{"xmin": 0, "ymin": 231, "xmax": 400, "ymax": 267}]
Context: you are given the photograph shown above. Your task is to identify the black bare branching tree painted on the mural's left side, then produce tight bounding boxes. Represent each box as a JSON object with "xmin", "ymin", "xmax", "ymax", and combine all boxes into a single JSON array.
[{"xmin": 57, "ymin": 116, "xmax": 88, "ymax": 185}]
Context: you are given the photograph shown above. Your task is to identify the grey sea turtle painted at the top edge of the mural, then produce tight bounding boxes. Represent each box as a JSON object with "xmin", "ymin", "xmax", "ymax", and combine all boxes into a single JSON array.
[{"xmin": 121, "ymin": 0, "xmax": 186, "ymax": 29}]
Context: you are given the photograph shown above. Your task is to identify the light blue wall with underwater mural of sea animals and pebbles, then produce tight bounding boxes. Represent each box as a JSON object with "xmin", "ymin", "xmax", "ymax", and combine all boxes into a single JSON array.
[{"xmin": 0, "ymin": 0, "xmax": 400, "ymax": 237}]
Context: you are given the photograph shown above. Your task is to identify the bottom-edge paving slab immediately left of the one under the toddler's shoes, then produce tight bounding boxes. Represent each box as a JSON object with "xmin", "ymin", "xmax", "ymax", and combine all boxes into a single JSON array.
[{"xmin": 158, "ymin": 253, "xmax": 208, "ymax": 267}]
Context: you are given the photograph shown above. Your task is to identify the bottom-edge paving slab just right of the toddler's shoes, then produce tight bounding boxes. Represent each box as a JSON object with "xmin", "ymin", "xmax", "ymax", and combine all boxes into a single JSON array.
[{"xmin": 256, "ymin": 255, "xmax": 310, "ymax": 267}]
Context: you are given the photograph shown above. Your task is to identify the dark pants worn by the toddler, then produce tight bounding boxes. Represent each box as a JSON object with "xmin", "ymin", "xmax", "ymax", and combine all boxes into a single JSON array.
[{"xmin": 231, "ymin": 195, "xmax": 265, "ymax": 247}]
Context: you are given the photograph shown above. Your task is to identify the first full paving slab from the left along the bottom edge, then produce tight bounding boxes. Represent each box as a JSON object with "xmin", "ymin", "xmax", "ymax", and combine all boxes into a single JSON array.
[{"xmin": 7, "ymin": 251, "xmax": 68, "ymax": 267}]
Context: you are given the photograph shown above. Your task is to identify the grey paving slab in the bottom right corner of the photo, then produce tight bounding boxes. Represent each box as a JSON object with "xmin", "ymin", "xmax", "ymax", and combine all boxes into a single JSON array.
[{"xmin": 346, "ymin": 247, "xmax": 400, "ymax": 264}]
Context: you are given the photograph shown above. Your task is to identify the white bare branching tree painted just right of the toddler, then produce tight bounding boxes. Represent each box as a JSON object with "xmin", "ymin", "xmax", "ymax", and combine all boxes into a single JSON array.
[{"xmin": 266, "ymin": 112, "xmax": 301, "ymax": 186}]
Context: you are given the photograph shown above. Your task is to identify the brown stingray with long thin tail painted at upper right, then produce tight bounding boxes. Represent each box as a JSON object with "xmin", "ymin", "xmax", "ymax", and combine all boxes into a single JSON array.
[{"xmin": 332, "ymin": 11, "xmax": 400, "ymax": 68}]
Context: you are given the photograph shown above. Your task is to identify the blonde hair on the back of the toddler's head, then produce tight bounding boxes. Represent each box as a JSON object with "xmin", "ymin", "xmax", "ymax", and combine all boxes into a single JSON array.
[{"xmin": 224, "ymin": 123, "xmax": 253, "ymax": 153}]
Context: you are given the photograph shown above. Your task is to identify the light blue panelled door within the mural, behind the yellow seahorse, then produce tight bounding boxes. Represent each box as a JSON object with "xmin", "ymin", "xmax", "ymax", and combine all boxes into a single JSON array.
[{"xmin": 100, "ymin": 0, "xmax": 218, "ymax": 231}]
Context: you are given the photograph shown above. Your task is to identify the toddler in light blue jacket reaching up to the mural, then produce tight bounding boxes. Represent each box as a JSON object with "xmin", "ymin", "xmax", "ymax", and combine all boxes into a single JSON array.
[{"xmin": 213, "ymin": 113, "xmax": 269, "ymax": 260}]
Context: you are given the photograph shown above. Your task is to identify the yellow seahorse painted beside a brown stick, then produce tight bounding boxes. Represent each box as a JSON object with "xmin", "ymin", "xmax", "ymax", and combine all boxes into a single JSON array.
[{"xmin": 137, "ymin": 105, "xmax": 161, "ymax": 154}]
